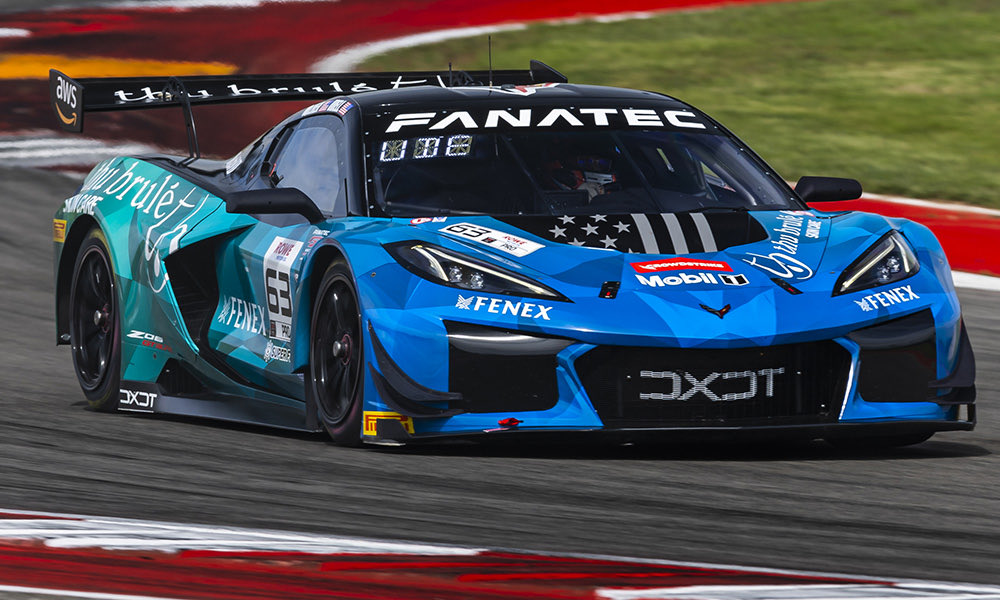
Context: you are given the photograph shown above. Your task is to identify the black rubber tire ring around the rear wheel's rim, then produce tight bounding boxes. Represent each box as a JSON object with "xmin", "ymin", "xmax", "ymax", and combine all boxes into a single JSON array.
[{"xmin": 69, "ymin": 228, "xmax": 121, "ymax": 412}]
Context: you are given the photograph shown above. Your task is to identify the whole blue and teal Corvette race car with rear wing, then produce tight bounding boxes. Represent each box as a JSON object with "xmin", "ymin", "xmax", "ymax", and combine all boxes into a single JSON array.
[{"xmin": 50, "ymin": 61, "xmax": 975, "ymax": 445}]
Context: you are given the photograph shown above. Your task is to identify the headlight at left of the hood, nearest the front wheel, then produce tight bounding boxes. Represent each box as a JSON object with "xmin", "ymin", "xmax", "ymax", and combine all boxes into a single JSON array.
[{"xmin": 384, "ymin": 241, "xmax": 569, "ymax": 302}]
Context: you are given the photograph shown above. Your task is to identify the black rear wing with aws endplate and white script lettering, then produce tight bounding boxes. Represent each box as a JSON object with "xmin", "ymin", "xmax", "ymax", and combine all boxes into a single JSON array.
[{"xmin": 49, "ymin": 60, "xmax": 567, "ymax": 133}]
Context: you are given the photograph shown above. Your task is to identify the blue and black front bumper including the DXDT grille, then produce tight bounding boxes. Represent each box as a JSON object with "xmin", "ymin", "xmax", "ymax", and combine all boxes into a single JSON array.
[{"xmin": 365, "ymin": 309, "xmax": 975, "ymax": 443}]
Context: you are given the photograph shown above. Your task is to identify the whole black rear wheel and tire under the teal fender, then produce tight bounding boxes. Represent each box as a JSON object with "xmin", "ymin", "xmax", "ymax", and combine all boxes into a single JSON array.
[{"xmin": 69, "ymin": 228, "xmax": 122, "ymax": 412}]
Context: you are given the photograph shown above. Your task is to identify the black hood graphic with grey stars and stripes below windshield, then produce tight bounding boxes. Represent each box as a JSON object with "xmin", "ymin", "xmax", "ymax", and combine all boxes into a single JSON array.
[{"xmin": 499, "ymin": 212, "xmax": 767, "ymax": 254}]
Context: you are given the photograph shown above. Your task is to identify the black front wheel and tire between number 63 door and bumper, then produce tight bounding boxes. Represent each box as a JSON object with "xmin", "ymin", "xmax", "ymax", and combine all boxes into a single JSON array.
[{"xmin": 309, "ymin": 261, "xmax": 364, "ymax": 446}]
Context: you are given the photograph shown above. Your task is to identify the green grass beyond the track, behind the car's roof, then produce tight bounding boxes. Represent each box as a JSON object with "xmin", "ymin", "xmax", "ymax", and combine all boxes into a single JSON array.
[{"xmin": 358, "ymin": 0, "xmax": 1000, "ymax": 206}]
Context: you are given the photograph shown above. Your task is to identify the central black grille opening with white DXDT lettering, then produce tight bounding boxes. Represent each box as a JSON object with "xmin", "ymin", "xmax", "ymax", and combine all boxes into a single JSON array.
[{"xmin": 575, "ymin": 341, "xmax": 851, "ymax": 428}]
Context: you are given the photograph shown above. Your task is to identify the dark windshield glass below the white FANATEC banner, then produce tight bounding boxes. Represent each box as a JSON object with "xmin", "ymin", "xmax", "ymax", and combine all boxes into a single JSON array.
[{"xmin": 370, "ymin": 129, "xmax": 801, "ymax": 216}]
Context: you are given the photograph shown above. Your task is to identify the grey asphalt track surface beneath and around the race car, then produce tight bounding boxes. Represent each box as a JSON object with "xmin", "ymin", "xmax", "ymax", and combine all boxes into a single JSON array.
[{"xmin": 0, "ymin": 168, "xmax": 1000, "ymax": 584}]
